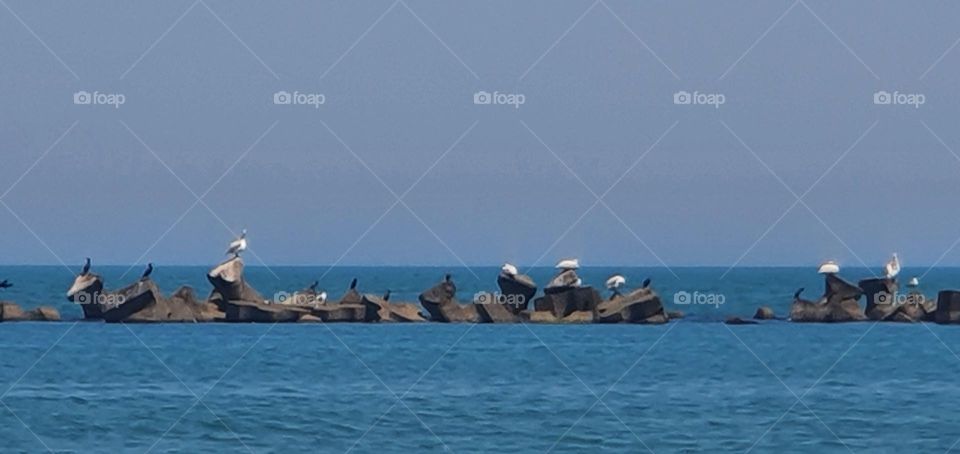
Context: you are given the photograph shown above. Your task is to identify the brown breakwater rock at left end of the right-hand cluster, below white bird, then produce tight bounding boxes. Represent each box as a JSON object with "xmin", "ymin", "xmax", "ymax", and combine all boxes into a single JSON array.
[{"xmin": 790, "ymin": 274, "xmax": 867, "ymax": 322}]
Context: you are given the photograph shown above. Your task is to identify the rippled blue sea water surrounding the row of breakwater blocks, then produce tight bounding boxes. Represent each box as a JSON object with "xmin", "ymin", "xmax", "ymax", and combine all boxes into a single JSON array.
[{"xmin": 0, "ymin": 267, "xmax": 960, "ymax": 453}]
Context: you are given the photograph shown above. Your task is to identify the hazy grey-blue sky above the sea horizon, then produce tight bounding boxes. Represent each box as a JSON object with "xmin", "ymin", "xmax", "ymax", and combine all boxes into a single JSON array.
[{"xmin": 0, "ymin": 0, "xmax": 960, "ymax": 267}]
